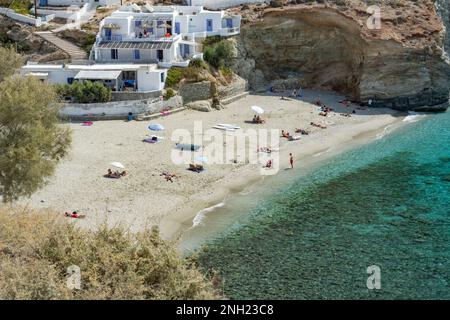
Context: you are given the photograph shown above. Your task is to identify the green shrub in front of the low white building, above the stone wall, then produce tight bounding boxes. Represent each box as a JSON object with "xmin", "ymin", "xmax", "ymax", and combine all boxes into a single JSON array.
[{"xmin": 56, "ymin": 81, "xmax": 111, "ymax": 103}]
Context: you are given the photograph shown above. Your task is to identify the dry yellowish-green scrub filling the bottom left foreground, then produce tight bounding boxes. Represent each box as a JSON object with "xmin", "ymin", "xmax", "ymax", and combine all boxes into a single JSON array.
[{"xmin": 0, "ymin": 209, "xmax": 219, "ymax": 299}]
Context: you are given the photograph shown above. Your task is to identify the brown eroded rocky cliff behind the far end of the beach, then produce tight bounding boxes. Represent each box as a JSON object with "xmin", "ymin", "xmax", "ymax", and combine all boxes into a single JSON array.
[{"xmin": 230, "ymin": 0, "xmax": 450, "ymax": 110}]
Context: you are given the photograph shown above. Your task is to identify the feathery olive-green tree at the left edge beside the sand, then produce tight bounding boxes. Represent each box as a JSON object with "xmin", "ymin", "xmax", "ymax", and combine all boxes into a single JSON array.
[{"xmin": 0, "ymin": 77, "xmax": 71, "ymax": 203}]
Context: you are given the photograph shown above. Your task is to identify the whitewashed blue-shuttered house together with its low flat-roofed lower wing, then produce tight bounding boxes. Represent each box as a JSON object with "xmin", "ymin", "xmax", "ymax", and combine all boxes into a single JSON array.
[{"xmin": 21, "ymin": 5, "xmax": 241, "ymax": 93}]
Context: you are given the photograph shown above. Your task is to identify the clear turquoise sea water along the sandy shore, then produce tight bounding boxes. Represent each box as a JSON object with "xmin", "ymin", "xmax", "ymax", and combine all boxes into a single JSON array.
[{"xmin": 193, "ymin": 112, "xmax": 450, "ymax": 299}]
